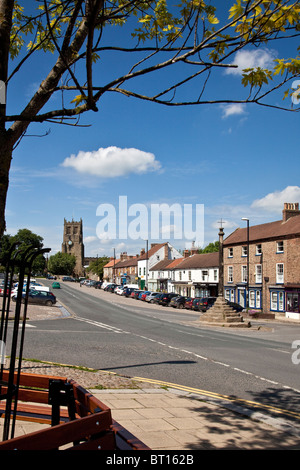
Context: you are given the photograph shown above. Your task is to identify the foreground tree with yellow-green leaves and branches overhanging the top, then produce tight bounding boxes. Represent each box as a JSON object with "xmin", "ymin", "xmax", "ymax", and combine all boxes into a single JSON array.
[{"xmin": 0, "ymin": 0, "xmax": 300, "ymax": 235}]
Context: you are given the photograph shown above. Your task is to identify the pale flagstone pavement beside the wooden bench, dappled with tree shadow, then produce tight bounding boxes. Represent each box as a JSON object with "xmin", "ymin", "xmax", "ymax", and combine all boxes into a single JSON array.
[{"xmin": 0, "ymin": 282, "xmax": 300, "ymax": 452}]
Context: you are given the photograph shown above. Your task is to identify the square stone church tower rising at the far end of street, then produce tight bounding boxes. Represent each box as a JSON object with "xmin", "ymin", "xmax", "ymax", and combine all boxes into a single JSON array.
[{"xmin": 61, "ymin": 219, "xmax": 84, "ymax": 276}]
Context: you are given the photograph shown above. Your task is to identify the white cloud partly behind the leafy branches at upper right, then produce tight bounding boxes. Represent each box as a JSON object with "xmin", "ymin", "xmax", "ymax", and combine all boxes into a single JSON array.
[{"xmin": 225, "ymin": 49, "xmax": 276, "ymax": 75}]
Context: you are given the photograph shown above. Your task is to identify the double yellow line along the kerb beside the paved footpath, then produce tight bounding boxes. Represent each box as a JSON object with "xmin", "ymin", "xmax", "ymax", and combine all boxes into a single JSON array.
[{"xmin": 132, "ymin": 377, "xmax": 300, "ymax": 419}]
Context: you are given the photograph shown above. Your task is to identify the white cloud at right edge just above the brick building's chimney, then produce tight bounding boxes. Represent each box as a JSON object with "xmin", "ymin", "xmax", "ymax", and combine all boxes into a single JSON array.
[{"xmin": 251, "ymin": 186, "xmax": 300, "ymax": 212}]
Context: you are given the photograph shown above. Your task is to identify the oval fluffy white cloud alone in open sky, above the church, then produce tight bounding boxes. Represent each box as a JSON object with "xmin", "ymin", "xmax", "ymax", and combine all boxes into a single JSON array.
[{"xmin": 62, "ymin": 147, "xmax": 161, "ymax": 178}]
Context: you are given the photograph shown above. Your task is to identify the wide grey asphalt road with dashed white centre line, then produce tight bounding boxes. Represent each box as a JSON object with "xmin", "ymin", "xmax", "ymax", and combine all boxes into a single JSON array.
[{"xmin": 17, "ymin": 283, "xmax": 300, "ymax": 420}]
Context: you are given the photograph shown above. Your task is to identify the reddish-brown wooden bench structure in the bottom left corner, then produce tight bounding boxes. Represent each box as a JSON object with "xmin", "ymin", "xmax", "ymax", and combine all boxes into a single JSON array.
[{"xmin": 0, "ymin": 371, "xmax": 149, "ymax": 451}]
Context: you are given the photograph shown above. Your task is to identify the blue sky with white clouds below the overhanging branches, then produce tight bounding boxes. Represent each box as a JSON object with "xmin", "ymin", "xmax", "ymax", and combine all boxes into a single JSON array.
[{"xmin": 6, "ymin": 1, "xmax": 300, "ymax": 256}]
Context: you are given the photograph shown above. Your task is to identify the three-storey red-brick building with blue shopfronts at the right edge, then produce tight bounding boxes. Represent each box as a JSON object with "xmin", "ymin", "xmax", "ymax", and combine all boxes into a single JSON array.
[{"xmin": 223, "ymin": 203, "xmax": 300, "ymax": 319}]
